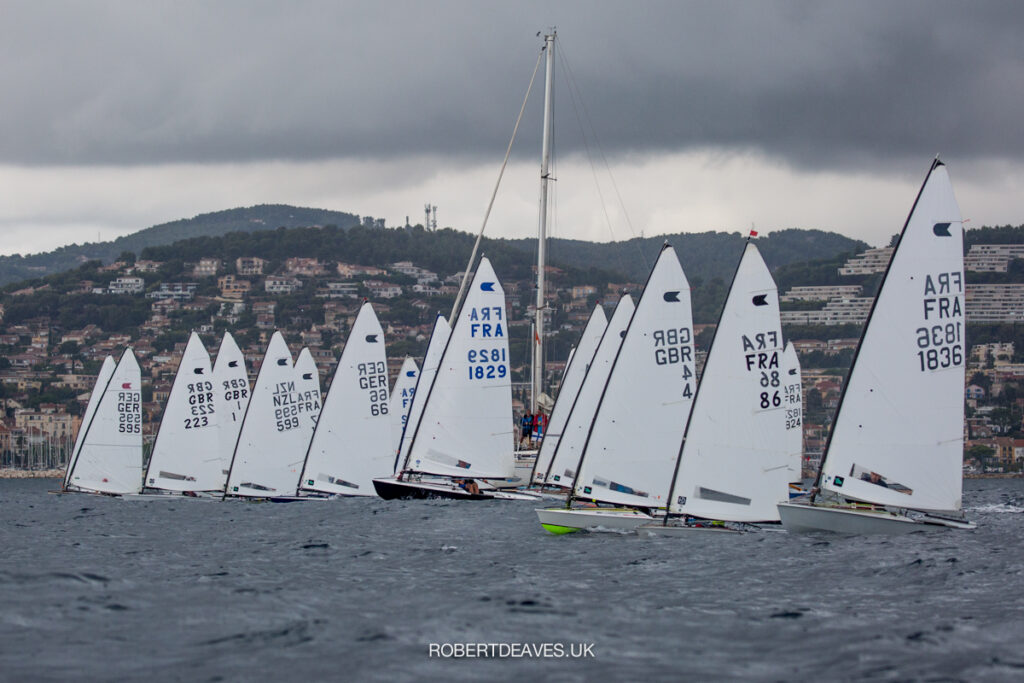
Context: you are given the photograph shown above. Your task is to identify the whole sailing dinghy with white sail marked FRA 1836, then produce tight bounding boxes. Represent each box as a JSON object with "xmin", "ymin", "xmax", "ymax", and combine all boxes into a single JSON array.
[{"xmin": 778, "ymin": 159, "xmax": 974, "ymax": 533}]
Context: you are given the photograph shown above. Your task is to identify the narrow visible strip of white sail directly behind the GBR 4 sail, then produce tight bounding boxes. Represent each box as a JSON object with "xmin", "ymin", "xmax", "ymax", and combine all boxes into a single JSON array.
[{"xmin": 547, "ymin": 294, "xmax": 636, "ymax": 488}]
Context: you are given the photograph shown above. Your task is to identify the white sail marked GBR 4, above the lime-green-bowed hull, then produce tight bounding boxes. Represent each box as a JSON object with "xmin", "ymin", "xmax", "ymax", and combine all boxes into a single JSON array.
[{"xmin": 575, "ymin": 245, "xmax": 696, "ymax": 508}]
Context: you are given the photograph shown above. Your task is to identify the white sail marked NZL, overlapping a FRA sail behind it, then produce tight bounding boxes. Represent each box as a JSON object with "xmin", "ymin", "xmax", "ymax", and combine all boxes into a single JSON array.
[{"xmin": 226, "ymin": 332, "xmax": 303, "ymax": 498}]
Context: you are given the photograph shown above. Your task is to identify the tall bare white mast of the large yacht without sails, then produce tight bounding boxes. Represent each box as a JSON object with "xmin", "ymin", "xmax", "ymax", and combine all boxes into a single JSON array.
[{"xmin": 529, "ymin": 31, "xmax": 557, "ymax": 414}]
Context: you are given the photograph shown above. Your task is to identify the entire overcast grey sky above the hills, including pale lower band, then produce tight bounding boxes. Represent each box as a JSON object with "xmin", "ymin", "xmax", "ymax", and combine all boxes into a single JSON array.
[{"xmin": 0, "ymin": 0, "xmax": 1024, "ymax": 254}]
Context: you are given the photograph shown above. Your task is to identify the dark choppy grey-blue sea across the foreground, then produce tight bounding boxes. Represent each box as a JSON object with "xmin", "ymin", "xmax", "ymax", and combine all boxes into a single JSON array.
[{"xmin": 0, "ymin": 479, "xmax": 1024, "ymax": 682}]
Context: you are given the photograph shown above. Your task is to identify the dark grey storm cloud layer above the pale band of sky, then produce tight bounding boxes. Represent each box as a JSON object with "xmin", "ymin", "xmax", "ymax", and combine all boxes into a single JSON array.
[{"xmin": 0, "ymin": 1, "xmax": 1024, "ymax": 167}]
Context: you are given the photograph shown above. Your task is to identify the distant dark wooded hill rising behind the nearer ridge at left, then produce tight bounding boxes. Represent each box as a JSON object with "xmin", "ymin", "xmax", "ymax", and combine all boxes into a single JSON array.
[{"xmin": 0, "ymin": 204, "xmax": 359, "ymax": 285}]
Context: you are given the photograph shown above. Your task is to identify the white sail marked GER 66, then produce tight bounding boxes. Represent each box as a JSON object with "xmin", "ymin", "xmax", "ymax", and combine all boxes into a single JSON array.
[{"xmin": 299, "ymin": 303, "xmax": 391, "ymax": 496}]
